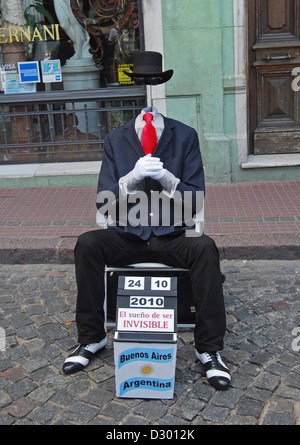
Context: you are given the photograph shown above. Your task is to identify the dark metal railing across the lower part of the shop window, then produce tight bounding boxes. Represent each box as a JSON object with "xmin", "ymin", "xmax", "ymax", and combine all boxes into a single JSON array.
[{"xmin": 0, "ymin": 87, "xmax": 146, "ymax": 164}]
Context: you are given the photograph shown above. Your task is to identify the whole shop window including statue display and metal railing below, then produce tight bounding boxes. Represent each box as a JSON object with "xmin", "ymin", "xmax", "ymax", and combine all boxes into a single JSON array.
[{"xmin": 0, "ymin": 0, "xmax": 146, "ymax": 164}]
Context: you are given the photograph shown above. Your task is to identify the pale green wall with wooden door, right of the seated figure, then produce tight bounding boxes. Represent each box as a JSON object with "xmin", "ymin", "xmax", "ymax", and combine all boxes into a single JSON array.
[{"xmin": 159, "ymin": 0, "xmax": 300, "ymax": 183}]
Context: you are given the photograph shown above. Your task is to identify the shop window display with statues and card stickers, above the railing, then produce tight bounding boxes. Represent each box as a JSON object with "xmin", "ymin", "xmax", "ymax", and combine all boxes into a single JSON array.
[{"xmin": 0, "ymin": 0, "xmax": 142, "ymax": 94}]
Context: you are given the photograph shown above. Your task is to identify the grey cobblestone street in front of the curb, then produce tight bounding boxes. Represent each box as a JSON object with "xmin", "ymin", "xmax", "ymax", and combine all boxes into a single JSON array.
[{"xmin": 0, "ymin": 260, "xmax": 300, "ymax": 426}]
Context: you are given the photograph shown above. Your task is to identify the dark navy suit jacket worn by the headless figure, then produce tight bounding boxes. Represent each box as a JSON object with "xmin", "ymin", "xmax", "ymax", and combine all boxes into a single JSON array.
[{"xmin": 97, "ymin": 117, "xmax": 205, "ymax": 239}]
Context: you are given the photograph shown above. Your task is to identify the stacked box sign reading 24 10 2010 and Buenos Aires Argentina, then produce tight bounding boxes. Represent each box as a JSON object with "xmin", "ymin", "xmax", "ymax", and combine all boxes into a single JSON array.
[{"xmin": 114, "ymin": 274, "xmax": 177, "ymax": 399}]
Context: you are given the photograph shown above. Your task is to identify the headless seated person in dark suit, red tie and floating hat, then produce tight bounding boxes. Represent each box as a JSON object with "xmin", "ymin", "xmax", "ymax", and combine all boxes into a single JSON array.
[{"xmin": 63, "ymin": 52, "xmax": 230, "ymax": 390}]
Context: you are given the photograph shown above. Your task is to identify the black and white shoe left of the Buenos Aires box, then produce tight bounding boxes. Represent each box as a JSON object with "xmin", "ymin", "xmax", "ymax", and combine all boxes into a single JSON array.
[{"xmin": 63, "ymin": 337, "xmax": 107, "ymax": 374}]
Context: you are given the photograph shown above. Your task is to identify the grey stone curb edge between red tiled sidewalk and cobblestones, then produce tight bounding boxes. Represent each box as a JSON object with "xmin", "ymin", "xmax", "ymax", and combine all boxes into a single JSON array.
[{"xmin": 0, "ymin": 233, "xmax": 300, "ymax": 264}]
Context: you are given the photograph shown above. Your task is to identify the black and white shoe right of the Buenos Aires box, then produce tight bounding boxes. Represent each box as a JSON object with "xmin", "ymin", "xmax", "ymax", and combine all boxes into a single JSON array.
[{"xmin": 196, "ymin": 351, "xmax": 231, "ymax": 390}]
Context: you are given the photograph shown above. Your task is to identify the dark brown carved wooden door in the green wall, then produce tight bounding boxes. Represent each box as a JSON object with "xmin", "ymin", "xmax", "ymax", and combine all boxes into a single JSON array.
[{"xmin": 247, "ymin": 0, "xmax": 300, "ymax": 155}]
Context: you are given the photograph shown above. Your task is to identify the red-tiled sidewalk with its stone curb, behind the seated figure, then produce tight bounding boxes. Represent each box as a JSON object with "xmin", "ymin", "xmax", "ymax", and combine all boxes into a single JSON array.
[{"xmin": 0, "ymin": 181, "xmax": 300, "ymax": 264}]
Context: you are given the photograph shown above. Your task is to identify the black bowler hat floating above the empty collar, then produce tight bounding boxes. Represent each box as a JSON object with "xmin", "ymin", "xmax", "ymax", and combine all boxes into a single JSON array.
[{"xmin": 124, "ymin": 51, "xmax": 173, "ymax": 85}]
